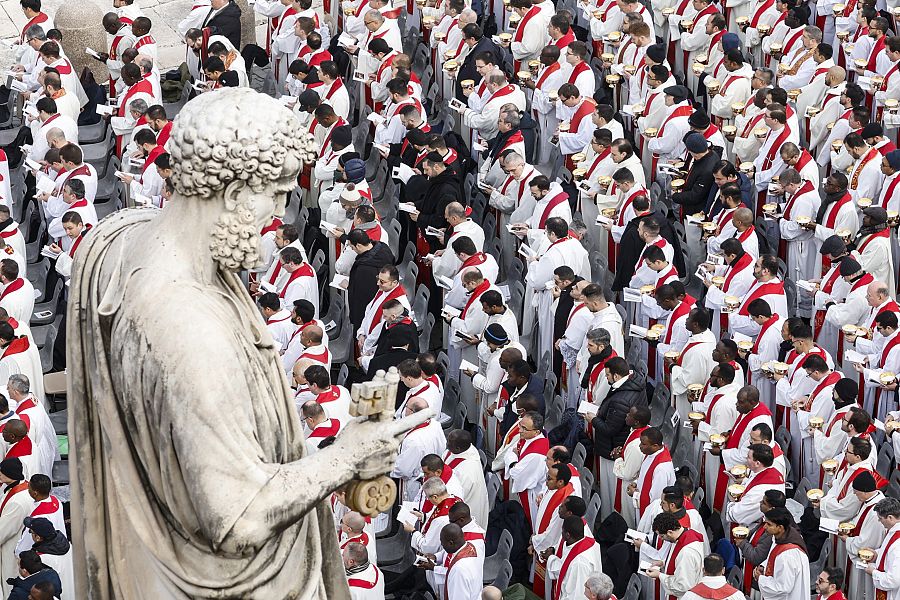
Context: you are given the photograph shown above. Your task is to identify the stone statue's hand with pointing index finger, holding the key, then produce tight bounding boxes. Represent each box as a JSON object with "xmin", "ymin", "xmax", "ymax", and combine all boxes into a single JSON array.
[{"xmin": 334, "ymin": 410, "xmax": 431, "ymax": 479}]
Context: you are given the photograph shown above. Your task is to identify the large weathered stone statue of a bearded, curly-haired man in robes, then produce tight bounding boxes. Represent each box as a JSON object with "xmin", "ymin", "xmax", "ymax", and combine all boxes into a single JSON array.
[{"xmin": 67, "ymin": 88, "xmax": 429, "ymax": 600}]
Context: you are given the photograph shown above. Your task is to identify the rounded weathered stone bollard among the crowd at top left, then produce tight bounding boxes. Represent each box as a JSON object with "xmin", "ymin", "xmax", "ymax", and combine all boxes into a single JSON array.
[{"xmin": 53, "ymin": 2, "xmax": 109, "ymax": 84}]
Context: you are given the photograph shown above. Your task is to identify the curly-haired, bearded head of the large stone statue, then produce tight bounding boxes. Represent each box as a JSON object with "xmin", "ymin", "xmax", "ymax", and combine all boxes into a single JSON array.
[{"xmin": 167, "ymin": 88, "xmax": 315, "ymax": 271}]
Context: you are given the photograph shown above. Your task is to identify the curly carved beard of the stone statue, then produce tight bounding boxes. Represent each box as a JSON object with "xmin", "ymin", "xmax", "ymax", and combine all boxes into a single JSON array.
[{"xmin": 209, "ymin": 198, "xmax": 260, "ymax": 271}]
